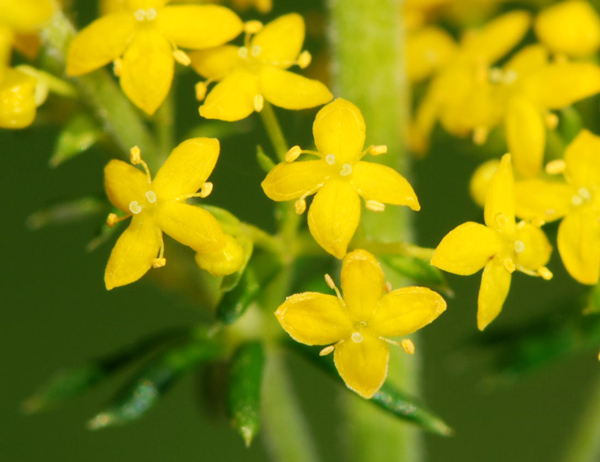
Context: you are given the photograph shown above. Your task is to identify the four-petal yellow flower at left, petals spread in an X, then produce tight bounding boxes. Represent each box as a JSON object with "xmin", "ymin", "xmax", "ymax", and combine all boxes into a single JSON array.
[{"xmin": 104, "ymin": 138, "xmax": 237, "ymax": 290}]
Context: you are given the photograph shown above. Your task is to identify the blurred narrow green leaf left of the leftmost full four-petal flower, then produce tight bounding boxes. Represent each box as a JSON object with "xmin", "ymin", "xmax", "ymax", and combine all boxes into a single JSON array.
[{"xmin": 27, "ymin": 197, "xmax": 109, "ymax": 230}]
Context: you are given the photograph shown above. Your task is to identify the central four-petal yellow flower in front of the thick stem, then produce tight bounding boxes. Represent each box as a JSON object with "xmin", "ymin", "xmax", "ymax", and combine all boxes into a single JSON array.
[{"xmin": 262, "ymin": 98, "xmax": 420, "ymax": 258}]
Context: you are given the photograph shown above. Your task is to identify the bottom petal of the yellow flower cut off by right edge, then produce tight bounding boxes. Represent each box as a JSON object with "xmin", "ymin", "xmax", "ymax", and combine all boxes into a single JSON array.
[{"xmin": 557, "ymin": 207, "xmax": 600, "ymax": 284}]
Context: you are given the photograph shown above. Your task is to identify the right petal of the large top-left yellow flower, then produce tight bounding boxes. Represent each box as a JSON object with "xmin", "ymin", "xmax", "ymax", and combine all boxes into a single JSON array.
[{"xmin": 161, "ymin": 5, "xmax": 243, "ymax": 49}]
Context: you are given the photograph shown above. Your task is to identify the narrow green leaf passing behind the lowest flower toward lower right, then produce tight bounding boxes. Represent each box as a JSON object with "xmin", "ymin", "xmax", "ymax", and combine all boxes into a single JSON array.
[{"xmin": 287, "ymin": 341, "xmax": 454, "ymax": 436}]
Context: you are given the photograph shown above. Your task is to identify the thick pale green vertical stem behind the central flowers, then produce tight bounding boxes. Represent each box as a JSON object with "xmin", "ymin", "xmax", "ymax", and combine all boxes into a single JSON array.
[{"xmin": 329, "ymin": 0, "xmax": 422, "ymax": 462}]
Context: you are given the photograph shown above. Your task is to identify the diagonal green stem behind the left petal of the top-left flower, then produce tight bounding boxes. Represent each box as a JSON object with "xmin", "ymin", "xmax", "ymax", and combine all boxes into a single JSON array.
[{"xmin": 41, "ymin": 8, "xmax": 155, "ymax": 164}]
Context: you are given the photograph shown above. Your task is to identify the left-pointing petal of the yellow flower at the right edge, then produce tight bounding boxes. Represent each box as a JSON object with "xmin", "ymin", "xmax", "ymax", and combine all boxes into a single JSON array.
[{"xmin": 515, "ymin": 179, "xmax": 574, "ymax": 222}]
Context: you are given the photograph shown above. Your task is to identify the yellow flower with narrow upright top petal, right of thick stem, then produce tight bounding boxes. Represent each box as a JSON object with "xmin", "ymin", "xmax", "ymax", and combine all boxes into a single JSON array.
[{"xmin": 431, "ymin": 154, "xmax": 552, "ymax": 330}]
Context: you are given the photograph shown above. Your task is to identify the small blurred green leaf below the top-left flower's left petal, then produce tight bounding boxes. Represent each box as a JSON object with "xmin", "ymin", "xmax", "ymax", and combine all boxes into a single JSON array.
[{"xmin": 49, "ymin": 112, "xmax": 104, "ymax": 167}]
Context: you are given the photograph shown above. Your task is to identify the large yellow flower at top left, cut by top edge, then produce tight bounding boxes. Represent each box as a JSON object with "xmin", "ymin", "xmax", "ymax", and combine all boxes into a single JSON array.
[{"xmin": 67, "ymin": 0, "xmax": 242, "ymax": 114}]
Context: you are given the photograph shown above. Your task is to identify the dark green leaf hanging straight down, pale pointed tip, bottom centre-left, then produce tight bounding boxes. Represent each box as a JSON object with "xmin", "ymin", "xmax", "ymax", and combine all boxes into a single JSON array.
[{"xmin": 227, "ymin": 342, "xmax": 265, "ymax": 447}]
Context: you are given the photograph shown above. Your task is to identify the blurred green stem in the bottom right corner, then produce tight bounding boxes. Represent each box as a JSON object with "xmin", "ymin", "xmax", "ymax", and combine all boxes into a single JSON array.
[{"xmin": 563, "ymin": 376, "xmax": 600, "ymax": 462}]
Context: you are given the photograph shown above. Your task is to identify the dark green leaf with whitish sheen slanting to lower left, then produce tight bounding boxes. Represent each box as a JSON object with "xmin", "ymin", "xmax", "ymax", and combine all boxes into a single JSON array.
[{"xmin": 88, "ymin": 332, "xmax": 224, "ymax": 430}]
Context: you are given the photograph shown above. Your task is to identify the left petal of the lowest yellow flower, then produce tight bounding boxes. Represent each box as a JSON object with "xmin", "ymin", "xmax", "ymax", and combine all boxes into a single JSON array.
[{"xmin": 275, "ymin": 292, "xmax": 352, "ymax": 345}]
